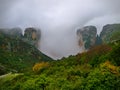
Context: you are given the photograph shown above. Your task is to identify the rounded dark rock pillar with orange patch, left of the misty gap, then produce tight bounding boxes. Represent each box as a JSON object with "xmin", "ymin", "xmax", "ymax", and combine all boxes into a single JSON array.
[{"xmin": 23, "ymin": 28, "xmax": 41, "ymax": 47}]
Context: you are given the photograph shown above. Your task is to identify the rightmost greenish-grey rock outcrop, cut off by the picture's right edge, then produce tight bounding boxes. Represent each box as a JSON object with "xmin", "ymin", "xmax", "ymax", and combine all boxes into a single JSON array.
[{"xmin": 100, "ymin": 24, "xmax": 120, "ymax": 43}]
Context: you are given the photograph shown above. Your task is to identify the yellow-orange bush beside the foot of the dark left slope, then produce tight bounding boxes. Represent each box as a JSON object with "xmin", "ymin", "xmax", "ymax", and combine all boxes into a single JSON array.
[{"xmin": 32, "ymin": 62, "xmax": 49, "ymax": 72}]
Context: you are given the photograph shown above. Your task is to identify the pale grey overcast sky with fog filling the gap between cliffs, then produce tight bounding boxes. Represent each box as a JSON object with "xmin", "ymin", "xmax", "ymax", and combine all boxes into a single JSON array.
[{"xmin": 0, "ymin": 0, "xmax": 120, "ymax": 58}]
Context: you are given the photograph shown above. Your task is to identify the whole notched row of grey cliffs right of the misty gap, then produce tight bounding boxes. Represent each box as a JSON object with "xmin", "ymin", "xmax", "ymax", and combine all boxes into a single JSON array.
[{"xmin": 77, "ymin": 24, "xmax": 120, "ymax": 50}]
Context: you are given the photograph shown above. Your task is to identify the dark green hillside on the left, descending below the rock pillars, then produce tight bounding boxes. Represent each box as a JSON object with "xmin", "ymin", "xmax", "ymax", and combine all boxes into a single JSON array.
[{"xmin": 0, "ymin": 32, "xmax": 52, "ymax": 74}]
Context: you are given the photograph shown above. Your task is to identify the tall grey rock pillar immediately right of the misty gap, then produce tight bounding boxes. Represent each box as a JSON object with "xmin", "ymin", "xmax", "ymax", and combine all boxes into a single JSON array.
[{"xmin": 77, "ymin": 26, "xmax": 97, "ymax": 49}]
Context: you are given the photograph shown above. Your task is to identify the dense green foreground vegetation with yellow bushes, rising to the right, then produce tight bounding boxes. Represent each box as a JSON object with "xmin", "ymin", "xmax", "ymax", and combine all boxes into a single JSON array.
[{"xmin": 0, "ymin": 42, "xmax": 120, "ymax": 90}]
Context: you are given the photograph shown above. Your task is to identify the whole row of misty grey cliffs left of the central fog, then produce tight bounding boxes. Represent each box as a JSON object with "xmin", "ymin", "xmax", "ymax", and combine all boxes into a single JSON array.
[{"xmin": 0, "ymin": 27, "xmax": 41, "ymax": 48}]
